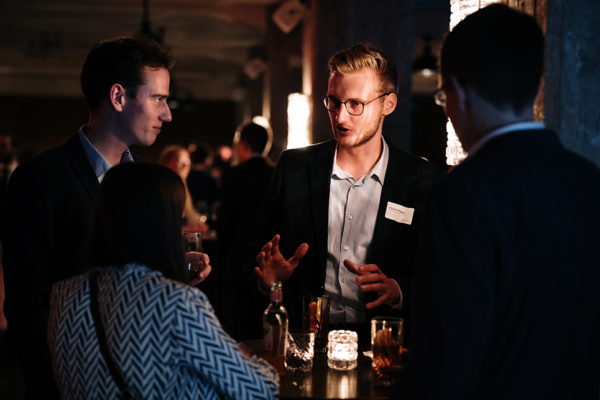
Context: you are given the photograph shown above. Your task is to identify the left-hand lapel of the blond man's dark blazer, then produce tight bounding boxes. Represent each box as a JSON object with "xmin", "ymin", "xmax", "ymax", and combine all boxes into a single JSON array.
[{"xmin": 308, "ymin": 140, "xmax": 335, "ymax": 273}]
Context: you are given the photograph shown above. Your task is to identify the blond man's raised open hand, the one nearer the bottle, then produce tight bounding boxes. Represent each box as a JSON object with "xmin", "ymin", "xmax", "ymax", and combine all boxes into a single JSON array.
[{"xmin": 254, "ymin": 235, "xmax": 308, "ymax": 293}]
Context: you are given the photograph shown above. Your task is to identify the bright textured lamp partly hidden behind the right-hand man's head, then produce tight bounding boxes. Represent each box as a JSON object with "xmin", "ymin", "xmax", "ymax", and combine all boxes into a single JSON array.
[{"xmin": 446, "ymin": 0, "xmax": 500, "ymax": 165}]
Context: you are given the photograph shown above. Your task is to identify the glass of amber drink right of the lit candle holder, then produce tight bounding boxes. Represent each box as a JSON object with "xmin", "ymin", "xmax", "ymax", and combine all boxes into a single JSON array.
[{"xmin": 371, "ymin": 317, "xmax": 403, "ymax": 386}]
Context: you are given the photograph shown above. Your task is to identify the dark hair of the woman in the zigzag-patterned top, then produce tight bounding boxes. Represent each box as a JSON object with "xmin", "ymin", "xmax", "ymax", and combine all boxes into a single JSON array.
[{"xmin": 88, "ymin": 164, "xmax": 186, "ymax": 282}]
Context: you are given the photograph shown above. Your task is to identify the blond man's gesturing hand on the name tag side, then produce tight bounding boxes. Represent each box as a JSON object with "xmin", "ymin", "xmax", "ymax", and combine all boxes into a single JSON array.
[{"xmin": 344, "ymin": 260, "xmax": 401, "ymax": 310}]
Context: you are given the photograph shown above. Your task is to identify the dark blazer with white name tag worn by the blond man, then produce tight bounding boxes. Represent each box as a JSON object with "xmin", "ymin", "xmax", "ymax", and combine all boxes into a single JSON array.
[{"xmin": 245, "ymin": 141, "xmax": 438, "ymax": 332}]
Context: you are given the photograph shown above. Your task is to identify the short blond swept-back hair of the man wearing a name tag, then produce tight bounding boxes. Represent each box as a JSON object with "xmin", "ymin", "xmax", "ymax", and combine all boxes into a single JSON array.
[{"xmin": 328, "ymin": 42, "xmax": 398, "ymax": 93}]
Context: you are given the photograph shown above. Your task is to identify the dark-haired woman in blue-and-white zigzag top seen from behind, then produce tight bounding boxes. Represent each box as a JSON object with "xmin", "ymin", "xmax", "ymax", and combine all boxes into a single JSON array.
[{"xmin": 48, "ymin": 164, "xmax": 278, "ymax": 399}]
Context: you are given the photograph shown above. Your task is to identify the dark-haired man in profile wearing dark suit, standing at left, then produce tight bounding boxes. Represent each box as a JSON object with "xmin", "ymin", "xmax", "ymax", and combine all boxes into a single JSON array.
[{"xmin": 3, "ymin": 37, "xmax": 179, "ymax": 399}]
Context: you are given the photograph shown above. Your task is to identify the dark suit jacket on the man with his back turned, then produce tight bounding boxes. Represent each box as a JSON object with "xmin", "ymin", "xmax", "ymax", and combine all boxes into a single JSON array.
[{"xmin": 397, "ymin": 130, "xmax": 600, "ymax": 400}]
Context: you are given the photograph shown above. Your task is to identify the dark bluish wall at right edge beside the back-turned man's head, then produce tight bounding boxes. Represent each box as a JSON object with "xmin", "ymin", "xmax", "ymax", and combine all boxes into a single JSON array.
[{"xmin": 544, "ymin": 0, "xmax": 600, "ymax": 166}]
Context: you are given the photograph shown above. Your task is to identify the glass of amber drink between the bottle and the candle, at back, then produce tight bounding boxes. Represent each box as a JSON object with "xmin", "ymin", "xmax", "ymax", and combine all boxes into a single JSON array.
[{"xmin": 302, "ymin": 294, "xmax": 329, "ymax": 352}]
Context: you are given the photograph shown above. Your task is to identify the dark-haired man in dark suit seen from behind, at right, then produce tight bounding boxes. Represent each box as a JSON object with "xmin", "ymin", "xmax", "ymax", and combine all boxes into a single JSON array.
[{"xmin": 396, "ymin": 5, "xmax": 600, "ymax": 400}]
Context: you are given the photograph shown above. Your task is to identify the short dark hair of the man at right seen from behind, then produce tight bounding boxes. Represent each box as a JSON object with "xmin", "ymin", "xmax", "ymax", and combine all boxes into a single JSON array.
[{"xmin": 440, "ymin": 4, "xmax": 544, "ymax": 112}]
